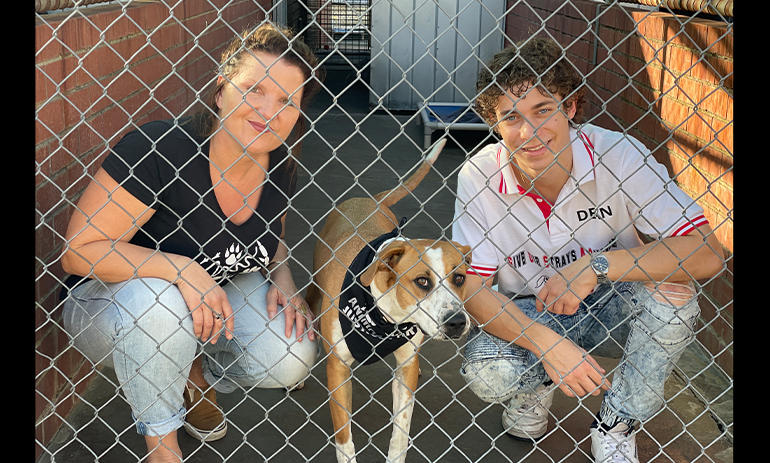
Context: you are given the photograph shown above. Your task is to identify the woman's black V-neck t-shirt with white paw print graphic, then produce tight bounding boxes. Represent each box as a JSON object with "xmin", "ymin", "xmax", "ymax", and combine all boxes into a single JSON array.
[{"xmin": 62, "ymin": 118, "xmax": 297, "ymax": 297}]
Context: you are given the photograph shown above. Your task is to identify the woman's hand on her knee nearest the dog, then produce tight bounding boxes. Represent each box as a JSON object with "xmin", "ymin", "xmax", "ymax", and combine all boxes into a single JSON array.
[{"xmin": 267, "ymin": 265, "xmax": 315, "ymax": 342}]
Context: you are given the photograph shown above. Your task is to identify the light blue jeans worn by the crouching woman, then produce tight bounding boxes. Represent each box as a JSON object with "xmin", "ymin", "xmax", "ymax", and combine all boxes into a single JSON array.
[{"xmin": 63, "ymin": 272, "xmax": 316, "ymax": 436}]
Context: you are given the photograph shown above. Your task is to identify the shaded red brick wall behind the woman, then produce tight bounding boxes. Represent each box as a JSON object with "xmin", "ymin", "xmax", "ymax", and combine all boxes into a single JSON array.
[{"xmin": 35, "ymin": 0, "xmax": 270, "ymax": 458}]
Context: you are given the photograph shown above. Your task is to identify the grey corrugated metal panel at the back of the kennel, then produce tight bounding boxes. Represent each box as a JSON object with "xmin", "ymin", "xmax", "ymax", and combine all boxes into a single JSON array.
[{"xmin": 369, "ymin": 0, "xmax": 505, "ymax": 110}]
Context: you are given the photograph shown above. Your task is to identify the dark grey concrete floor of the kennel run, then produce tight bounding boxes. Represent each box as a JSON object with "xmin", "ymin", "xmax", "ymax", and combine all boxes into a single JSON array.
[{"xmin": 41, "ymin": 63, "xmax": 733, "ymax": 463}]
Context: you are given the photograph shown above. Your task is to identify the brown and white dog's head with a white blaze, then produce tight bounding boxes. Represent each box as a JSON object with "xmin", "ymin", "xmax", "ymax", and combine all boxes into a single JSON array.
[{"xmin": 361, "ymin": 240, "xmax": 471, "ymax": 339}]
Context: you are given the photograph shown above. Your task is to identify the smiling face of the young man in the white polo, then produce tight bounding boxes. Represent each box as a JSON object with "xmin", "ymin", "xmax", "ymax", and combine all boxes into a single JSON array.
[{"xmin": 495, "ymin": 85, "xmax": 575, "ymax": 176}]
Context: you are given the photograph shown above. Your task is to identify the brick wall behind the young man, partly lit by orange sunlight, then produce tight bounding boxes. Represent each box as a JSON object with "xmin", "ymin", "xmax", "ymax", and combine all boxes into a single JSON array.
[{"xmin": 506, "ymin": 0, "xmax": 733, "ymax": 376}]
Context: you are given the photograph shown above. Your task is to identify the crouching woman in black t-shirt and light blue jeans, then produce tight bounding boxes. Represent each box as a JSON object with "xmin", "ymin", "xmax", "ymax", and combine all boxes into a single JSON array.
[{"xmin": 62, "ymin": 25, "xmax": 320, "ymax": 462}]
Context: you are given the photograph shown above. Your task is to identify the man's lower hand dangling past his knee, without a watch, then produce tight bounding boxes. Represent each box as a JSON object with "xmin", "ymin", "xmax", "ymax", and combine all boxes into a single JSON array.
[{"xmin": 542, "ymin": 338, "xmax": 612, "ymax": 397}]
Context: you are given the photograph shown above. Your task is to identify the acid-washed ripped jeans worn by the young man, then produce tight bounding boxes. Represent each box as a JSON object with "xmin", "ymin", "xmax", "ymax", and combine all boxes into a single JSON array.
[{"xmin": 460, "ymin": 282, "xmax": 700, "ymax": 426}]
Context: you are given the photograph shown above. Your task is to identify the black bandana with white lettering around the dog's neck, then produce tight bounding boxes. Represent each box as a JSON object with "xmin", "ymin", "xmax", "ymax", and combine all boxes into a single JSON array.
[{"xmin": 339, "ymin": 218, "xmax": 418, "ymax": 365}]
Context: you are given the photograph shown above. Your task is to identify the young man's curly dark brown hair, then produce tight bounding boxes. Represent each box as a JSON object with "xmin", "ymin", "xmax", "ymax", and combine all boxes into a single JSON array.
[{"xmin": 475, "ymin": 37, "xmax": 585, "ymax": 127}]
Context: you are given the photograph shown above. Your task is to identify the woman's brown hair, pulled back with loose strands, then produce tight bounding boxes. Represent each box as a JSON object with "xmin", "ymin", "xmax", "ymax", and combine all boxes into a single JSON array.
[{"xmin": 194, "ymin": 22, "xmax": 325, "ymax": 170}]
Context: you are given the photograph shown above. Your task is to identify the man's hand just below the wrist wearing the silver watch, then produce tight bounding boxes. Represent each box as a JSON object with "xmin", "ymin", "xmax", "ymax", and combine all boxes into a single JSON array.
[{"xmin": 535, "ymin": 255, "xmax": 597, "ymax": 315}]
